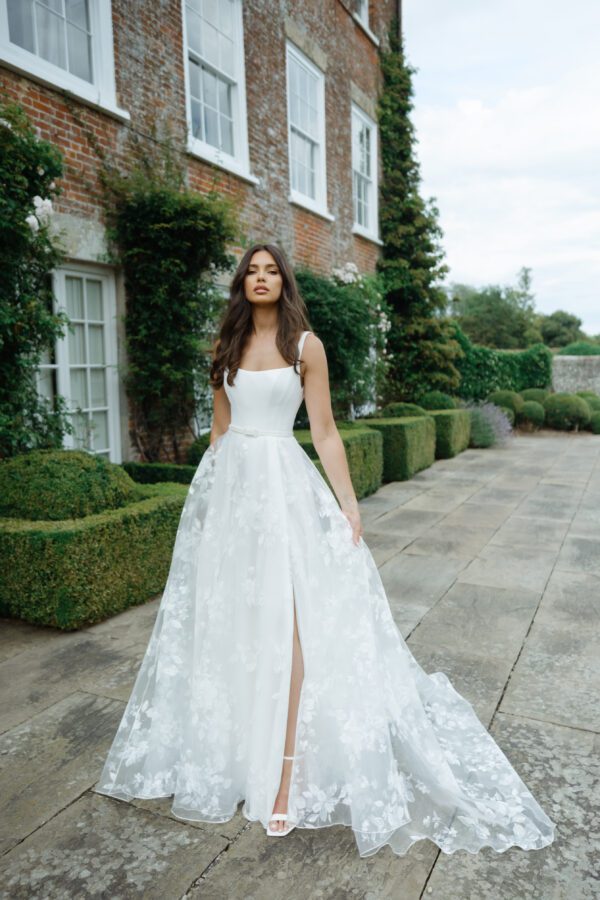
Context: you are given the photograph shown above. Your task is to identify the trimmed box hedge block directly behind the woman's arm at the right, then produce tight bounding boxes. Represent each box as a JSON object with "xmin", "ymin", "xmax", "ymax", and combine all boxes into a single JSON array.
[{"xmin": 294, "ymin": 423, "xmax": 383, "ymax": 500}]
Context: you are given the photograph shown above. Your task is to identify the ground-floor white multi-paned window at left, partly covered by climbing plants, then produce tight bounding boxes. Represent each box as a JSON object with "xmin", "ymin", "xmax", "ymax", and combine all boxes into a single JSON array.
[{"xmin": 38, "ymin": 265, "xmax": 121, "ymax": 463}]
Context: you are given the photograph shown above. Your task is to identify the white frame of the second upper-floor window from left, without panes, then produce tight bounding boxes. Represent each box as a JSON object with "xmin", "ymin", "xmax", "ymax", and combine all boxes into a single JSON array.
[{"xmin": 181, "ymin": 0, "xmax": 259, "ymax": 184}]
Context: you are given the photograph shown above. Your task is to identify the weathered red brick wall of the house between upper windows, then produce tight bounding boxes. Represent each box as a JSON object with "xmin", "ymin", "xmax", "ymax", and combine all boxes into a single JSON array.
[{"xmin": 0, "ymin": 0, "xmax": 396, "ymax": 272}]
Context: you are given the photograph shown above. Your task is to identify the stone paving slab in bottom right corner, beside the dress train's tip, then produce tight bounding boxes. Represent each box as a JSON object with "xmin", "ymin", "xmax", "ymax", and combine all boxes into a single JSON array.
[{"xmin": 423, "ymin": 713, "xmax": 600, "ymax": 900}]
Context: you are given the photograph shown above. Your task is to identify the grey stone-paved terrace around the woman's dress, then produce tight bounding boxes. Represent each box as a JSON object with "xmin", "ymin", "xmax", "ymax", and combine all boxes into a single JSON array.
[{"xmin": 0, "ymin": 432, "xmax": 600, "ymax": 900}]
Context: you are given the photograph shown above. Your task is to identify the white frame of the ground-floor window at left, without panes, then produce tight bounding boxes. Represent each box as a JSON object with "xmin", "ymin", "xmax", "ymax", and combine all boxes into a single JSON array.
[{"xmin": 45, "ymin": 263, "xmax": 122, "ymax": 463}]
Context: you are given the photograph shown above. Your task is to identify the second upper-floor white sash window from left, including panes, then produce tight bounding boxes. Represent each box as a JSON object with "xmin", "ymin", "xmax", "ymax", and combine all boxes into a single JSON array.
[{"xmin": 182, "ymin": 0, "xmax": 258, "ymax": 183}]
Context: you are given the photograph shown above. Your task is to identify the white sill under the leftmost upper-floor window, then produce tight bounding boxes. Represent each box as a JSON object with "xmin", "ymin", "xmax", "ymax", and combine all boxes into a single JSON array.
[{"xmin": 0, "ymin": 44, "xmax": 131, "ymax": 122}]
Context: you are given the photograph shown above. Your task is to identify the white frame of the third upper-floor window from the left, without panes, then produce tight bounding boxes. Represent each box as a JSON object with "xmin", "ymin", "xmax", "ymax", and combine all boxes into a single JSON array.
[{"xmin": 285, "ymin": 41, "xmax": 335, "ymax": 222}]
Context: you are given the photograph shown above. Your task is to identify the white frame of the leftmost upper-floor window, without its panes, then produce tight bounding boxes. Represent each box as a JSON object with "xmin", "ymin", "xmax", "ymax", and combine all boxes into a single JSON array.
[{"xmin": 0, "ymin": 0, "xmax": 131, "ymax": 121}]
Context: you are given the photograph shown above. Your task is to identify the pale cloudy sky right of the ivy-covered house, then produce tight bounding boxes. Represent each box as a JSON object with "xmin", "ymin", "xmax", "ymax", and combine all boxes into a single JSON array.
[{"xmin": 403, "ymin": 0, "xmax": 600, "ymax": 335}]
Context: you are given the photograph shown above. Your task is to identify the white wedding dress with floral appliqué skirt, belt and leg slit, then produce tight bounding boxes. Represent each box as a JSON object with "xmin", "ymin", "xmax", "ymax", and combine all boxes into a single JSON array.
[{"xmin": 95, "ymin": 332, "xmax": 554, "ymax": 856}]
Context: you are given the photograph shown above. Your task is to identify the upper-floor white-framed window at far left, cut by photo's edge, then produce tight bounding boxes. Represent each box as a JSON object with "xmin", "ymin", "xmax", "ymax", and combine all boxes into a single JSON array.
[{"xmin": 0, "ymin": 0, "xmax": 129, "ymax": 119}]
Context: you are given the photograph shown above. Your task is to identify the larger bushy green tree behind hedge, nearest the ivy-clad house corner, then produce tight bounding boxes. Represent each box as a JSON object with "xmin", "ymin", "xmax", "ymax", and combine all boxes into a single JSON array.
[{"xmin": 450, "ymin": 267, "xmax": 542, "ymax": 350}]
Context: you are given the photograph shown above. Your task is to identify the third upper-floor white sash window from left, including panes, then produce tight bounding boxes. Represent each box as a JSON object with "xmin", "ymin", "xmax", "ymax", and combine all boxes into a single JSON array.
[{"xmin": 286, "ymin": 42, "xmax": 333, "ymax": 219}]
